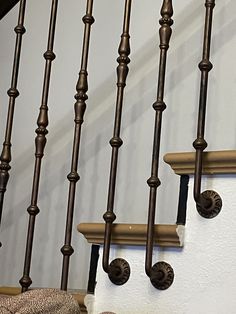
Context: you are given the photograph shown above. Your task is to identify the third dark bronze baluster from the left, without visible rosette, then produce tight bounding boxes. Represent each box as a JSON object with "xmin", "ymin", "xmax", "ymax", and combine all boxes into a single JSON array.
[{"xmin": 61, "ymin": 0, "xmax": 94, "ymax": 290}]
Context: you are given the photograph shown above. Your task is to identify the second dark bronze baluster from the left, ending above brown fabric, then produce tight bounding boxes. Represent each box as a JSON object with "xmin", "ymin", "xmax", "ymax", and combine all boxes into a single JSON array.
[{"xmin": 20, "ymin": 0, "xmax": 58, "ymax": 292}]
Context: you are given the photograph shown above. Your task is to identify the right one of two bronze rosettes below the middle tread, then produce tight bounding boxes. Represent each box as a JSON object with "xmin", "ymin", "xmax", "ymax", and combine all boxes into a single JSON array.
[{"xmin": 150, "ymin": 262, "xmax": 174, "ymax": 290}]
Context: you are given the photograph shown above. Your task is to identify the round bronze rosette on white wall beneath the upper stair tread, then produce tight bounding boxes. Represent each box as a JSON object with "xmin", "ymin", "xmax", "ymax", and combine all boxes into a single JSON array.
[{"xmin": 197, "ymin": 190, "xmax": 222, "ymax": 219}]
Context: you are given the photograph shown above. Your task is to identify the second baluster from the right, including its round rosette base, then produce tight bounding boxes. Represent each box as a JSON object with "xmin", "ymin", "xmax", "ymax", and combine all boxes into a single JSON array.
[{"xmin": 145, "ymin": 0, "xmax": 173, "ymax": 289}]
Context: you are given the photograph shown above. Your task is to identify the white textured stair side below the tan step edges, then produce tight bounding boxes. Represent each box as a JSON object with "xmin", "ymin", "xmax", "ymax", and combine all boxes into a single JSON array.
[{"xmin": 91, "ymin": 176, "xmax": 236, "ymax": 314}]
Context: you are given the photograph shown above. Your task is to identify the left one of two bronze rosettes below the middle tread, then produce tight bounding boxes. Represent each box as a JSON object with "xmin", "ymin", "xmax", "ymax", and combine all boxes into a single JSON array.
[{"xmin": 108, "ymin": 258, "xmax": 130, "ymax": 286}]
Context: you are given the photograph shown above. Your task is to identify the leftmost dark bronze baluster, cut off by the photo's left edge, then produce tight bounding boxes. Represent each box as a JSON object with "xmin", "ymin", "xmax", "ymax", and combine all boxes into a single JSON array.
[{"xmin": 0, "ymin": 0, "xmax": 26, "ymax": 233}]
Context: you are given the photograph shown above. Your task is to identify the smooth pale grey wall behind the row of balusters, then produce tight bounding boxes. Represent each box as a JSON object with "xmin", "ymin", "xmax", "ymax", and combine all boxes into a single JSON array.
[{"xmin": 0, "ymin": 0, "xmax": 236, "ymax": 288}]
